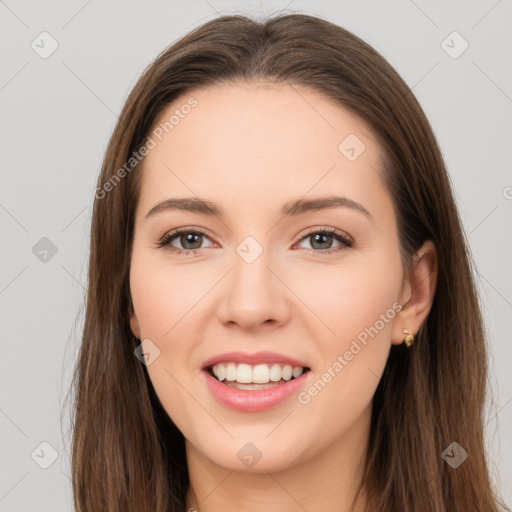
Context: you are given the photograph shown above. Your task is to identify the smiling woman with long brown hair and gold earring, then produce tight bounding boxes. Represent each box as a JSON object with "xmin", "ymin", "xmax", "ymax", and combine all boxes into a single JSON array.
[{"xmin": 72, "ymin": 15, "xmax": 510, "ymax": 512}]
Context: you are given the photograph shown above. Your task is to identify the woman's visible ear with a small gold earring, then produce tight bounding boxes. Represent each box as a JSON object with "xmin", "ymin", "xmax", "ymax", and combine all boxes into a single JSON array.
[{"xmin": 392, "ymin": 240, "xmax": 438, "ymax": 345}]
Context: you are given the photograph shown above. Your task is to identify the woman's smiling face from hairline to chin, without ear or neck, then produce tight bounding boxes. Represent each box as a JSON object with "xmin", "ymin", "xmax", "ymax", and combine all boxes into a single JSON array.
[{"xmin": 130, "ymin": 84, "xmax": 403, "ymax": 471}]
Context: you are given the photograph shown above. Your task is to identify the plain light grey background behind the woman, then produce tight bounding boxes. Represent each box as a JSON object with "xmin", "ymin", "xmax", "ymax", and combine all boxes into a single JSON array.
[{"xmin": 0, "ymin": 0, "xmax": 512, "ymax": 512}]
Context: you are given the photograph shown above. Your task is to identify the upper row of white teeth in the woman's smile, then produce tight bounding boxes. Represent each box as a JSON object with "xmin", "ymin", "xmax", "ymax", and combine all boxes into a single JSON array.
[{"xmin": 212, "ymin": 363, "xmax": 304, "ymax": 384}]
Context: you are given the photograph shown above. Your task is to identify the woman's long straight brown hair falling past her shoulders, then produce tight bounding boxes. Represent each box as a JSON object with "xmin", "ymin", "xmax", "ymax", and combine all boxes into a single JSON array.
[{"xmin": 67, "ymin": 14, "xmax": 504, "ymax": 512}]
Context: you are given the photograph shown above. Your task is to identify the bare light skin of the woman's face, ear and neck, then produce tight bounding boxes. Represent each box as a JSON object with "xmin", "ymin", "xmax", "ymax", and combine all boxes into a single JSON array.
[{"xmin": 130, "ymin": 83, "xmax": 437, "ymax": 512}]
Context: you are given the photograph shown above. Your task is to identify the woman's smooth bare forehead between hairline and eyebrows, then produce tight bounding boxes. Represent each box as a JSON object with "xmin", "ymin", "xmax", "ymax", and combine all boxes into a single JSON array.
[{"xmin": 134, "ymin": 83, "xmax": 390, "ymax": 221}]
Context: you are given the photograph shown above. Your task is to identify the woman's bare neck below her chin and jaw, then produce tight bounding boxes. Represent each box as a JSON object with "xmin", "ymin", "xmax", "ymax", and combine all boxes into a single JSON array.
[{"xmin": 185, "ymin": 405, "xmax": 371, "ymax": 512}]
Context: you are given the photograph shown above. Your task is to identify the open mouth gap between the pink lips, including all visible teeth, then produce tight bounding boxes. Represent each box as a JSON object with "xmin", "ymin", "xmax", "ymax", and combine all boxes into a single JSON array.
[{"xmin": 205, "ymin": 363, "xmax": 311, "ymax": 391}]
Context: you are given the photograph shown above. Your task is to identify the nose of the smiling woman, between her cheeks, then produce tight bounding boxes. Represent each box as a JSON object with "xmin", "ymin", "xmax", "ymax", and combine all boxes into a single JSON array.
[{"xmin": 219, "ymin": 238, "xmax": 290, "ymax": 329}]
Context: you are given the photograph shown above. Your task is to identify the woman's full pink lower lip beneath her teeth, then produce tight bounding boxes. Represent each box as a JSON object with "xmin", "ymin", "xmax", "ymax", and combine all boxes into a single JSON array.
[{"xmin": 203, "ymin": 371, "xmax": 311, "ymax": 412}]
